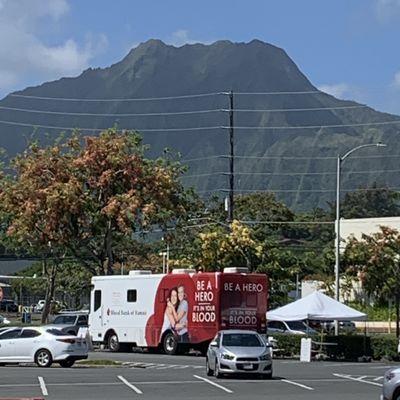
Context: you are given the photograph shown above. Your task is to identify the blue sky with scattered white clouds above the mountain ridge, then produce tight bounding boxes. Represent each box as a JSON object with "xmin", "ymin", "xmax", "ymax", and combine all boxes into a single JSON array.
[{"xmin": 0, "ymin": 0, "xmax": 400, "ymax": 114}]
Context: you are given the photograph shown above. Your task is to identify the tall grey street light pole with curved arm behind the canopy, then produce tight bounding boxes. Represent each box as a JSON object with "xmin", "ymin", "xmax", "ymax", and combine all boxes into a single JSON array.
[{"xmin": 335, "ymin": 143, "xmax": 386, "ymax": 335}]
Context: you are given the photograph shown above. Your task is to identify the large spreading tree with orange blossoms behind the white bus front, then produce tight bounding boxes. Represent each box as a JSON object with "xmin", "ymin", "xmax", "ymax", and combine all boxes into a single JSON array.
[{"xmin": 0, "ymin": 129, "xmax": 190, "ymax": 274}]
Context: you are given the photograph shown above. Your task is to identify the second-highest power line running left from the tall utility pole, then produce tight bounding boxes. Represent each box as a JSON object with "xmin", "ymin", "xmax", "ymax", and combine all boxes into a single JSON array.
[{"xmin": 0, "ymin": 106, "xmax": 220, "ymax": 117}]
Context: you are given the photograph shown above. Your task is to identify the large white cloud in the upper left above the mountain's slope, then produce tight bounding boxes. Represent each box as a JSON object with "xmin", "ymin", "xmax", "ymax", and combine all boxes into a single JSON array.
[{"xmin": 0, "ymin": 0, "xmax": 107, "ymax": 92}]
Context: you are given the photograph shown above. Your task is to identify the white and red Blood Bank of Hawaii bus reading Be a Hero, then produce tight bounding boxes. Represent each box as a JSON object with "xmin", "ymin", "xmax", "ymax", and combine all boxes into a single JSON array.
[{"xmin": 89, "ymin": 268, "xmax": 267, "ymax": 354}]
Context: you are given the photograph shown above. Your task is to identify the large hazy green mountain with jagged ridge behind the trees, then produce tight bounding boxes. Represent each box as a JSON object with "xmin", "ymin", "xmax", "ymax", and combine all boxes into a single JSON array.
[{"xmin": 0, "ymin": 40, "xmax": 400, "ymax": 209}]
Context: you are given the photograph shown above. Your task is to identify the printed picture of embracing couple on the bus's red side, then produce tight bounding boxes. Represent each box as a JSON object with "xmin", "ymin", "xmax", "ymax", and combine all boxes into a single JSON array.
[{"xmin": 161, "ymin": 285, "xmax": 189, "ymax": 343}]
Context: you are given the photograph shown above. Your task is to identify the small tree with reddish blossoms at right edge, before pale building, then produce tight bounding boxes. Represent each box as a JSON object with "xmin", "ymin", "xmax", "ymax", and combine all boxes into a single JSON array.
[{"xmin": 344, "ymin": 226, "xmax": 400, "ymax": 337}]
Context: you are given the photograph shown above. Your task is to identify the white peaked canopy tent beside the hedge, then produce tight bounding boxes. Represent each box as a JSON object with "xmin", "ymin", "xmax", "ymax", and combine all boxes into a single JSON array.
[{"xmin": 267, "ymin": 291, "xmax": 367, "ymax": 321}]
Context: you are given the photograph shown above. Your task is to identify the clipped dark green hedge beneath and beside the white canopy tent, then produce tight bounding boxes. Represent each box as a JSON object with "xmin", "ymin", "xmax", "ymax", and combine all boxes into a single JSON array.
[{"xmin": 273, "ymin": 334, "xmax": 399, "ymax": 361}]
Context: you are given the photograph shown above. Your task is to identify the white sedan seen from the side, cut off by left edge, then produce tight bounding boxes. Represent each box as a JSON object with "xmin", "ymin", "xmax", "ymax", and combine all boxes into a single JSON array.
[{"xmin": 0, "ymin": 327, "xmax": 88, "ymax": 368}]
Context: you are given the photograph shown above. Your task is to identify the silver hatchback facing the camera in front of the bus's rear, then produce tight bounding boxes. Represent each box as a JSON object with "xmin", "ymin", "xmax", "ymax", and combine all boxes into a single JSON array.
[{"xmin": 206, "ymin": 330, "xmax": 272, "ymax": 379}]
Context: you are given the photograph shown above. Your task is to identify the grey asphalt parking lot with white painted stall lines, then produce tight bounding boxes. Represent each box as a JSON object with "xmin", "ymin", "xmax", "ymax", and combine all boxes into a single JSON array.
[{"xmin": 0, "ymin": 352, "xmax": 393, "ymax": 400}]
